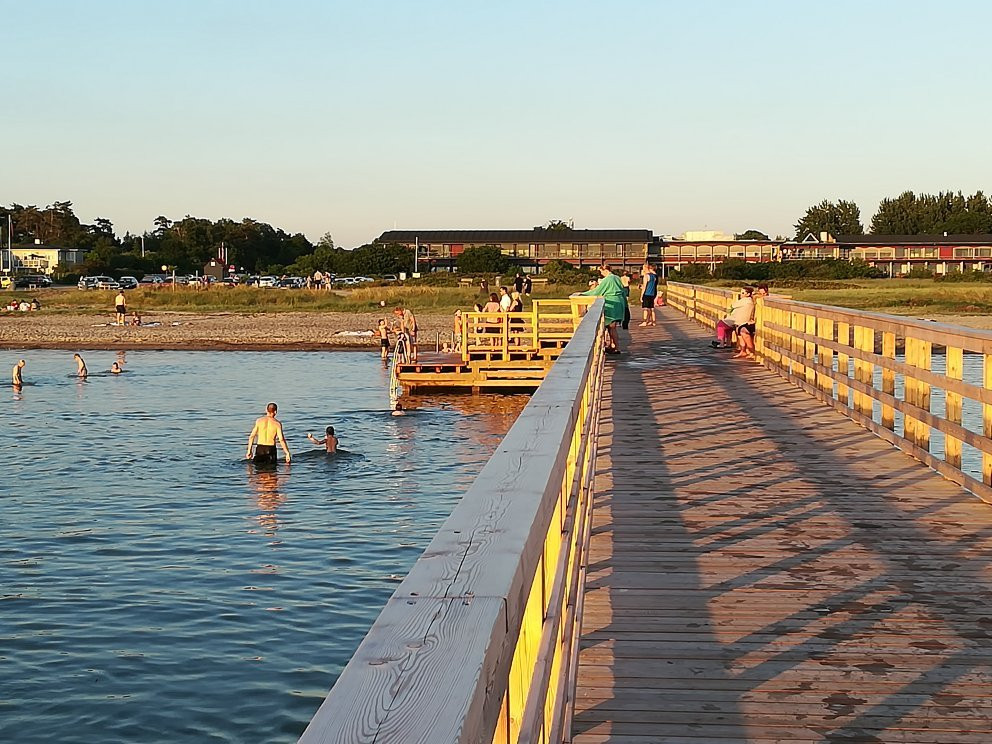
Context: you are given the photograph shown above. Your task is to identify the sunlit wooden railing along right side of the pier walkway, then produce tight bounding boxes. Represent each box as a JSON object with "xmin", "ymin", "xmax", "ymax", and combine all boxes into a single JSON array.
[{"xmin": 668, "ymin": 282, "xmax": 992, "ymax": 502}]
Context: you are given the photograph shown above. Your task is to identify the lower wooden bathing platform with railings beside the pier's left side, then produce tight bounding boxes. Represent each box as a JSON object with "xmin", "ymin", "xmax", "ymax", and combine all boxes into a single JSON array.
[{"xmin": 396, "ymin": 297, "xmax": 593, "ymax": 392}]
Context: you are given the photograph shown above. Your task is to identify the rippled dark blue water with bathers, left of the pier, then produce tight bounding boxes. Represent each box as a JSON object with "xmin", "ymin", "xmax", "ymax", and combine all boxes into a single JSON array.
[{"xmin": 0, "ymin": 351, "xmax": 525, "ymax": 743}]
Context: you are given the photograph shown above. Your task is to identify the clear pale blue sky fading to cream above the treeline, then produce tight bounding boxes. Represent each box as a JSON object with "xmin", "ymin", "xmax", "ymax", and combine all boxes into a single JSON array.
[{"xmin": 0, "ymin": 0, "xmax": 992, "ymax": 247}]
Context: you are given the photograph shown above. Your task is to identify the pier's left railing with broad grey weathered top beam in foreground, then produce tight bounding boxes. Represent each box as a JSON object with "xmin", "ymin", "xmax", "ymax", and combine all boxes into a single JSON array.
[{"xmin": 300, "ymin": 302, "xmax": 603, "ymax": 744}]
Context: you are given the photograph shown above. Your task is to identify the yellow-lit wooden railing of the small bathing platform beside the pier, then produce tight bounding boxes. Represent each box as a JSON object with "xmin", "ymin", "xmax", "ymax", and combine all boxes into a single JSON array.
[{"xmin": 461, "ymin": 297, "xmax": 595, "ymax": 361}]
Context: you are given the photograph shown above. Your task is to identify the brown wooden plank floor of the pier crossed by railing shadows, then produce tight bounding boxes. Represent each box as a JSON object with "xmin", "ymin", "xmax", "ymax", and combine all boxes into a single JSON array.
[{"xmin": 572, "ymin": 309, "xmax": 992, "ymax": 744}]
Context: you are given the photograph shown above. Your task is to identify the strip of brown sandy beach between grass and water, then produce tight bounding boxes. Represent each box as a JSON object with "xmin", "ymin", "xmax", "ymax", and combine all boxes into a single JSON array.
[{"xmin": 0, "ymin": 310, "xmax": 451, "ymax": 351}]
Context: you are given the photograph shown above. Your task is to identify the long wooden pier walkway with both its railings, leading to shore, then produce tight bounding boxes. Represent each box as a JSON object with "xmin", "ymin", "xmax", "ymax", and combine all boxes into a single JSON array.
[{"xmin": 301, "ymin": 284, "xmax": 992, "ymax": 744}]
